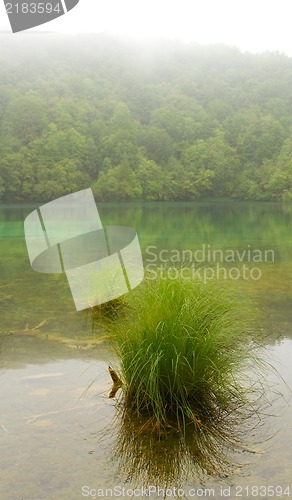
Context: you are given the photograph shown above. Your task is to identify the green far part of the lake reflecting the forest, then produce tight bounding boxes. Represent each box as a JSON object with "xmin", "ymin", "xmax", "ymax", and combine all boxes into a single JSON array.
[{"xmin": 0, "ymin": 202, "xmax": 292, "ymax": 337}]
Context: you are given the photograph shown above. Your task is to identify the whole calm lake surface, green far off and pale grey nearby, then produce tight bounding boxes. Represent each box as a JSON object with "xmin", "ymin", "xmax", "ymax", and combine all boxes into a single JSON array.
[{"xmin": 0, "ymin": 201, "xmax": 292, "ymax": 500}]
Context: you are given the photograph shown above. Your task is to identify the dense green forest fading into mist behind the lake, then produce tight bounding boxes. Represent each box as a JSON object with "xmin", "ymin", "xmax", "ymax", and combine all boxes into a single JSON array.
[{"xmin": 0, "ymin": 35, "xmax": 292, "ymax": 202}]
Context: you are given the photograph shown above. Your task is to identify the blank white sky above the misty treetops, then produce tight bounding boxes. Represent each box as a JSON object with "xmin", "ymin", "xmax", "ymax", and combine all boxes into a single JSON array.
[{"xmin": 0, "ymin": 0, "xmax": 292, "ymax": 56}]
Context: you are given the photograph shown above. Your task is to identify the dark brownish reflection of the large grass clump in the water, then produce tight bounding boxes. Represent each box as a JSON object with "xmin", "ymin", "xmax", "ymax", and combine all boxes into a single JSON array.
[{"xmin": 114, "ymin": 408, "xmax": 235, "ymax": 488}]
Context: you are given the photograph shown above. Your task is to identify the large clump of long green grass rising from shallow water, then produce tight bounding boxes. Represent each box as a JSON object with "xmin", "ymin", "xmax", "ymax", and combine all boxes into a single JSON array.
[{"xmin": 115, "ymin": 274, "xmax": 258, "ymax": 437}]
